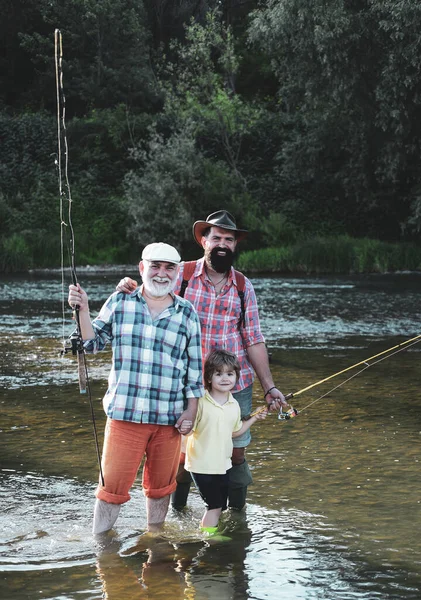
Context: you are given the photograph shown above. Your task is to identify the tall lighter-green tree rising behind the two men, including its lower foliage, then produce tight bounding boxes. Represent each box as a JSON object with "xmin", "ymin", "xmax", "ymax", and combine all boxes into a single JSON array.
[{"xmin": 126, "ymin": 11, "xmax": 260, "ymax": 243}]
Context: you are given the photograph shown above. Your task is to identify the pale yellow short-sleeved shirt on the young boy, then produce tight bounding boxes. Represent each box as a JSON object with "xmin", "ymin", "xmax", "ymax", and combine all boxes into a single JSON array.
[{"xmin": 185, "ymin": 392, "xmax": 242, "ymax": 475}]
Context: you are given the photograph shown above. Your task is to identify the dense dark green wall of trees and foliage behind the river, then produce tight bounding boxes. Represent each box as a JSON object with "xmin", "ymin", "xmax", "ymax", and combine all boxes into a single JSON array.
[{"xmin": 0, "ymin": 0, "xmax": 421, "ymax": 272}]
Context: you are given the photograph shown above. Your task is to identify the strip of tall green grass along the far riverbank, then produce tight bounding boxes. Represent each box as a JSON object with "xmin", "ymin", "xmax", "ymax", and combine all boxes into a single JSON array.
[{"xmin": 0, "ymin": 231, "xmax": 421, "ymax": 275}]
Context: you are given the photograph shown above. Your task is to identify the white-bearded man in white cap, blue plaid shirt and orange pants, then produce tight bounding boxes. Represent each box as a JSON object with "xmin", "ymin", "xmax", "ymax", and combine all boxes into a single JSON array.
[{"xmin": 68, "ymin": 242, "xmax": 204, "ymax": 534}]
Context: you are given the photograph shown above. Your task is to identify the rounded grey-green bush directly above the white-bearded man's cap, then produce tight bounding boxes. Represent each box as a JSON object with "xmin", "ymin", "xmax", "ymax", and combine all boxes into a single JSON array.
[{"xmin": 125, "ymin": 123, "xmax": 249, "ymax": 254}]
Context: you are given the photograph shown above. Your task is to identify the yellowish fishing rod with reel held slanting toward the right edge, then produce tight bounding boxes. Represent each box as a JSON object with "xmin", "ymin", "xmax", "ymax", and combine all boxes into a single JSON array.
[{"xmin": 250, "ymin": 334, "xmax": 421, "ymax": 421}]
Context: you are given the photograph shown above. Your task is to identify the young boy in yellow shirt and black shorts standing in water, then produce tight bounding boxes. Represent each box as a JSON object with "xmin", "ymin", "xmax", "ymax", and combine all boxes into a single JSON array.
[{"xmin": 185, "ymin": 350, "xmax": 267, "ymax": 534}]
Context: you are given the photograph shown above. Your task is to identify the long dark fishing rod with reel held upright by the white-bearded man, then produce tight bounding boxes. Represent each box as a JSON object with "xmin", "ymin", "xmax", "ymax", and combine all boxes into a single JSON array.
[{"xmin": 54, "ymin": 29, "xmax": 105, "ymax": 486}]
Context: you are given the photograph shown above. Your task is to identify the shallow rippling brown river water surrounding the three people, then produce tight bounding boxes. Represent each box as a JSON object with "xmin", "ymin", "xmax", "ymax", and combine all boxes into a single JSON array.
[{"xmin": 0, "ymin": 268, "xmax": 421, "ymax": 600}]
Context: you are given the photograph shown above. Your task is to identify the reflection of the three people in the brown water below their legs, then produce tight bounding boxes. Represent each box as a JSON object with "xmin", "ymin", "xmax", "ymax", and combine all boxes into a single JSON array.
[{"xmin": 97, "ymin": 516, "xmax": 251, "ymax": 600}]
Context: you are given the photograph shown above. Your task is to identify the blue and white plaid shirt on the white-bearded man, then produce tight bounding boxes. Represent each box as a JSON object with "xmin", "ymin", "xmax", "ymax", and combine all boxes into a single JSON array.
[{"xmin": 84, "ymin": 289, "xmax": 203, "ymax": 425}]
